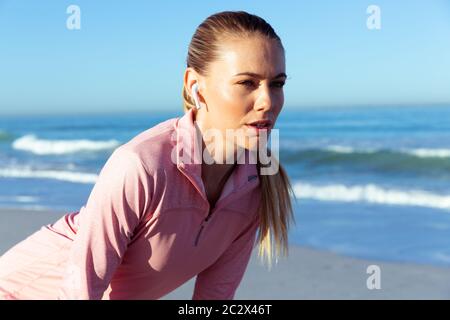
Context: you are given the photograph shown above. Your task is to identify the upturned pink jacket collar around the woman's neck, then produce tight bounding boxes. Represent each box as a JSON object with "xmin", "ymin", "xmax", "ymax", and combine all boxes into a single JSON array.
[{"xmin": 174, "ymin": 109, "xmax": 259, "ymax": 199}]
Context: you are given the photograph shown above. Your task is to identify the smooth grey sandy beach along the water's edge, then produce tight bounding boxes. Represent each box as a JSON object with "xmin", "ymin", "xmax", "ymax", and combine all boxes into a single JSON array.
[{"xmin": 0, "ymin": 208, "xmax": 450, "ymax": 300}]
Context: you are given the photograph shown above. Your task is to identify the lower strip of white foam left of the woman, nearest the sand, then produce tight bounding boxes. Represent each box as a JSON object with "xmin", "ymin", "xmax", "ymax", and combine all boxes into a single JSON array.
[{"xmin": 0, "ymin": 167, "xmax": 98, "ymax": 183}]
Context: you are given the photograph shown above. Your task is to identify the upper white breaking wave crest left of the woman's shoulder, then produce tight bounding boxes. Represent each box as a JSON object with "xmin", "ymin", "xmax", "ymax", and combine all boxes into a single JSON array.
[{"xmin": 12, "ymin": 134, "xmax": 120, "ymax": 155}]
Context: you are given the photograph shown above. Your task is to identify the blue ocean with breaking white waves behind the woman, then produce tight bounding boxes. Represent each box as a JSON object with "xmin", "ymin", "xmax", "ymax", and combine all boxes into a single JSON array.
[{"xmin": 0, "ymin": 106, "xmax": 450, "ymax": 267}]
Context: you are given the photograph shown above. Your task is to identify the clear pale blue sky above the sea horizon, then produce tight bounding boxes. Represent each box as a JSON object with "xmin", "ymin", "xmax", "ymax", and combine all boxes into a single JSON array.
[{"xmin": 0, "ymin": 0, "xmax": 450, "ymax": 114}]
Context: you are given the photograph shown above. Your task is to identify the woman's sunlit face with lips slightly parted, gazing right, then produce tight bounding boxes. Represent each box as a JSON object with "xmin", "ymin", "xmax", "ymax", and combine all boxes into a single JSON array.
[{"xmin": 187, "ymin": 37, "xmax": 286, "ymax": 160}]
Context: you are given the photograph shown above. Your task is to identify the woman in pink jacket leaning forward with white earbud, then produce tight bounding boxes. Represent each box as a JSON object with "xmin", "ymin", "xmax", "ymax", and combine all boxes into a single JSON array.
[{"xmin": 0, "ymin": 12, "xmax": 293, "ymax": 299}]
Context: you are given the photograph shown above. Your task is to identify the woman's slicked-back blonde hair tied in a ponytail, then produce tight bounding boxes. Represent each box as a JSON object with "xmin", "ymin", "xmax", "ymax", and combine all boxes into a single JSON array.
[{"xmin": 182, "ymin": 11, "xmax": 295, "ymax": 269}]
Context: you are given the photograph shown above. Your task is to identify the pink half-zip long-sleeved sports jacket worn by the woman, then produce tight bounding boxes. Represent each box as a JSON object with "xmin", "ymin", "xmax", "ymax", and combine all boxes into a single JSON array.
[{"xmin": 0, "ymin": 110, "xmax": 261, "ymax": 299}]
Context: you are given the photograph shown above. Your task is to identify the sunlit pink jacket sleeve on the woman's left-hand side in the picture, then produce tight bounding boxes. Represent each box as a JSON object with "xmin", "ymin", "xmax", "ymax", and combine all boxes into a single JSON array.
[{"xmin": 58, "ymin": 147, "xmax": 152, "ymax": 299}]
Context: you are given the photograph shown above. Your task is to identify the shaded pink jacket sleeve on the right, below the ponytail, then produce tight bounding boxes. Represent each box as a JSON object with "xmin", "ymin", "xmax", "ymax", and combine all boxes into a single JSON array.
[{"xmin": 192, "ymin": 216, "xmax": 259, "ymax": 300}]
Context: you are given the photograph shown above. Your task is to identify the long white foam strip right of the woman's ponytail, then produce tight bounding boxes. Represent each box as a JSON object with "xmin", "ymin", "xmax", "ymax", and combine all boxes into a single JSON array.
[{"xmin": 293, "ymin": 182, "xmax": 450, "ymax": 210}]
